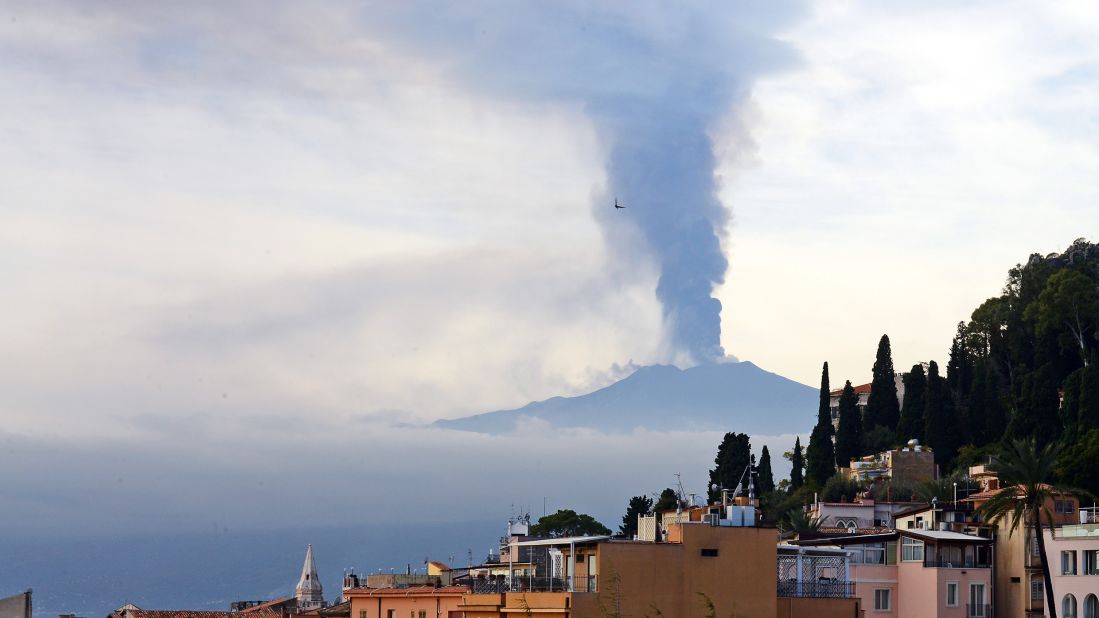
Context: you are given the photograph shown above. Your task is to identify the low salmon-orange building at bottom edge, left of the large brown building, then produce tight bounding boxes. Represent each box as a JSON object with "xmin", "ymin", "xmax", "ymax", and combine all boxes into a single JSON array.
[{"xmin": 344, "ymin": 586, "xmax": 469, "ymax": 618}]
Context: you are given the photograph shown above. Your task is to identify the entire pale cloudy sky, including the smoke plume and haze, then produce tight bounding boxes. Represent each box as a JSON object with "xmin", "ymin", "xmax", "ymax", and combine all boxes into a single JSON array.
[{"xmin": 0, "ymin": 0, "xmax": 1099, "ymax": 528}]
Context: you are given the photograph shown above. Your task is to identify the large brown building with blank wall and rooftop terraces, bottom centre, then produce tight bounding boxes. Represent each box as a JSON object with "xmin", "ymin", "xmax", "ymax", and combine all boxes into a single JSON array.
[{"xmin": 452, "ymin": 498, "xmax": 858, "ymax": 618}]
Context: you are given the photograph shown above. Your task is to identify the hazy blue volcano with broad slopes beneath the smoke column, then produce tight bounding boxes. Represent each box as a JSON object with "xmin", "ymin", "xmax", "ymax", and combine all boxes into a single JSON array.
[{"xmin": 435, "ymin": 361, "xmax": 818, "ymax": 435}]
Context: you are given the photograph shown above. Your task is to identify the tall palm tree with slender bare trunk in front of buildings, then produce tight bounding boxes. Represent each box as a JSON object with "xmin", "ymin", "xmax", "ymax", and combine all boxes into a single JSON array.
[{"xmin": 979, "ymin": 438, "xmax": 1079, "ymax": 618}]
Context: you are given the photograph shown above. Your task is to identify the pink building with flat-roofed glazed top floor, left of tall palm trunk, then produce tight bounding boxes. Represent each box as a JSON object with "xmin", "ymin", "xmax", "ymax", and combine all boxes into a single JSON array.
[{"xmin": 797, "ymin": 529, "xmax": 997, "ymax": 618}]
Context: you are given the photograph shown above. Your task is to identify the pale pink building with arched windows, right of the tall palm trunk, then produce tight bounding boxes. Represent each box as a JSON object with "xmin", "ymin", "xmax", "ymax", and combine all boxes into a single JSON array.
[{"xmin": 1031, "ymin": 508, "xmax": 1099, "ymax": 618}]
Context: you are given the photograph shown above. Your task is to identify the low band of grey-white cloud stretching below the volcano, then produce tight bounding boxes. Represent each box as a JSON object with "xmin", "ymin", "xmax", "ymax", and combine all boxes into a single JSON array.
[{"xmin": 0, "ymin": 417, "xmax": 808, "ymax": 537}]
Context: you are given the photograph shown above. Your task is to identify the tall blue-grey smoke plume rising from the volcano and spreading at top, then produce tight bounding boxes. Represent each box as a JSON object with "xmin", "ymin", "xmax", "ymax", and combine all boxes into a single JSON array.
[{"xmin": 373, "ymin": 2, "xmax": 800, "ymax": 362}]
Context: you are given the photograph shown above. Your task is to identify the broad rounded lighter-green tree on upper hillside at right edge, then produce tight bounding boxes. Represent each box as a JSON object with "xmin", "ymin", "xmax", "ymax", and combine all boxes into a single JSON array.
[{"xmin": 1024, "ymin": 268, "xmax": 1099, "ymax": 365}]
